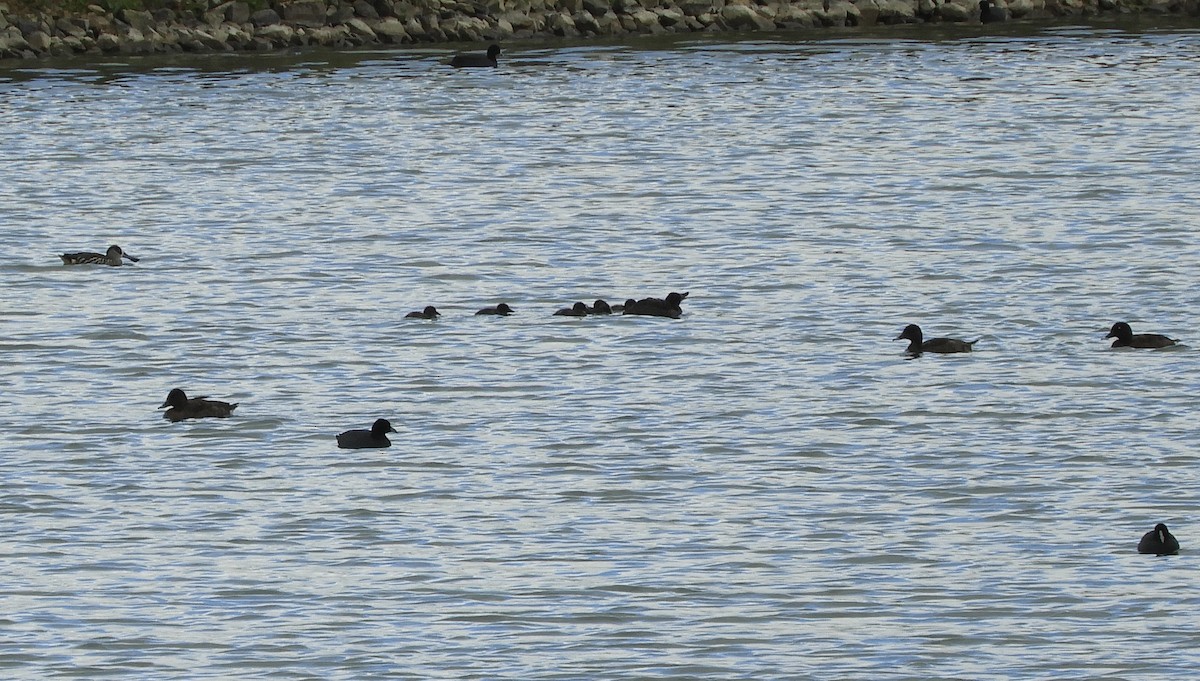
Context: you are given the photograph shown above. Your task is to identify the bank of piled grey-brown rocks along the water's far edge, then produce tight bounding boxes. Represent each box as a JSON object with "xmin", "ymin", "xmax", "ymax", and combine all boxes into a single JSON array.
[{"xmin": 0, "ymin": 0, "xmax": 1200, "ymax": 59}]
